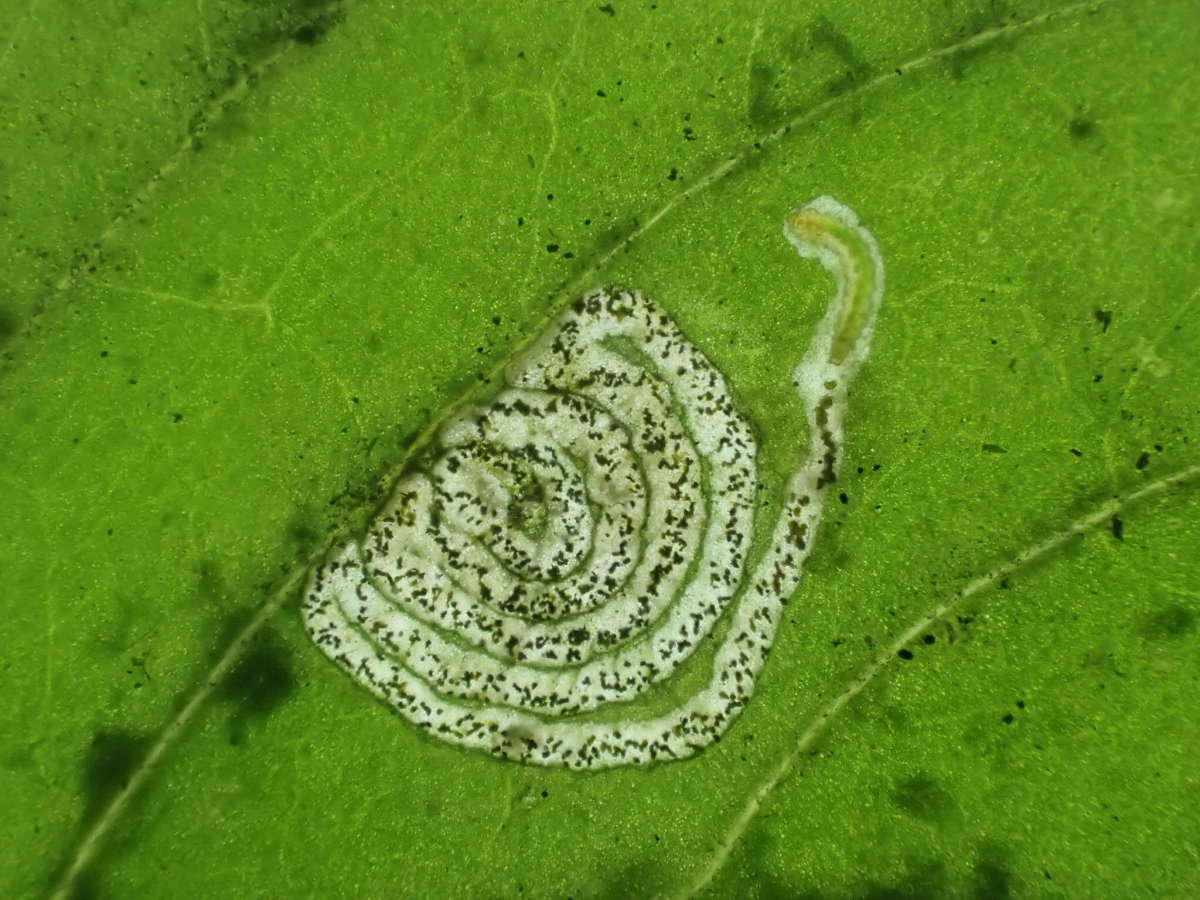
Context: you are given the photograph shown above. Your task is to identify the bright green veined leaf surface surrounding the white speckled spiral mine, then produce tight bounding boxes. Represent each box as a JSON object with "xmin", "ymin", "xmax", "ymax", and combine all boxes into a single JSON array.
[{"xmin": 0, "ymin": 0, "xmax": 1200, "ymax": 898}]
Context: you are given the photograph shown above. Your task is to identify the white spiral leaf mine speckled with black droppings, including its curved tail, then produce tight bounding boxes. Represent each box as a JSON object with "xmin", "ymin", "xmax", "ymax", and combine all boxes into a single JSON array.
[{"xmin": 302, "ymin": 197, "xmax": 883, "ymax": 768}]
